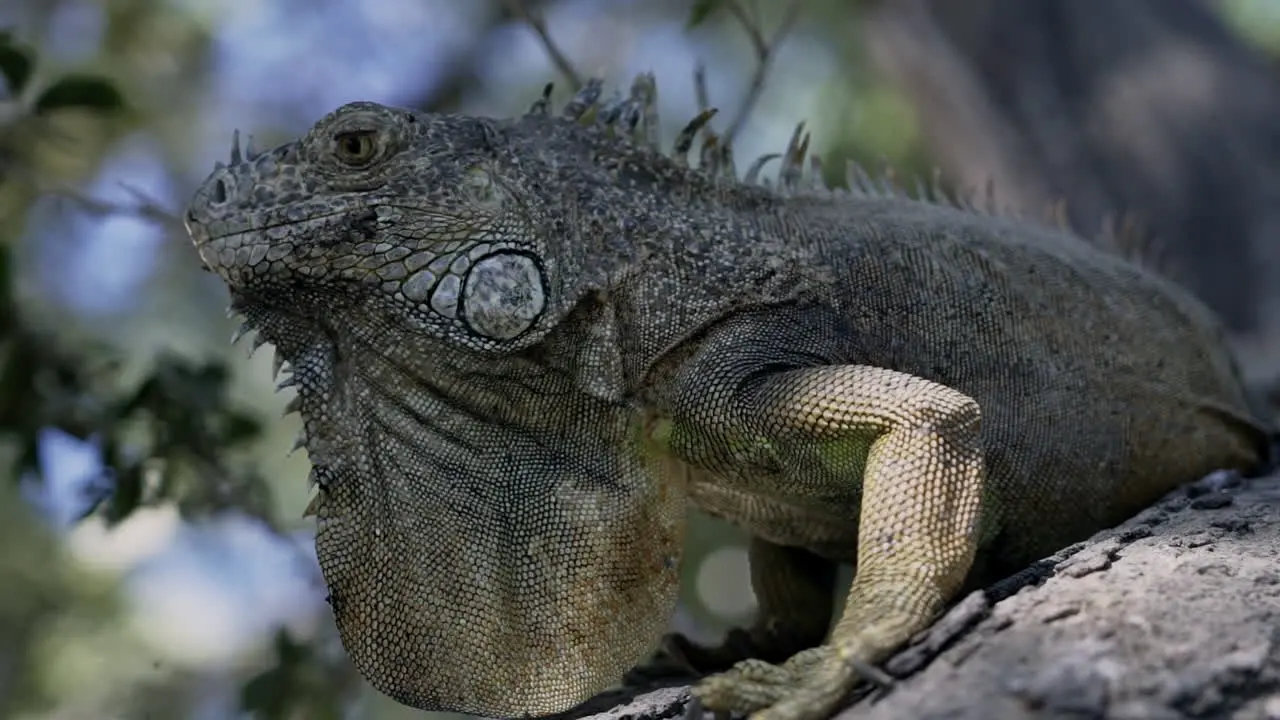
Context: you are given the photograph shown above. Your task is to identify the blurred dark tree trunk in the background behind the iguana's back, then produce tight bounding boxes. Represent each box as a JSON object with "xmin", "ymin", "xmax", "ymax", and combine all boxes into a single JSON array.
[{"xmin": 863, "ymin": 0, "xmax": 1280, "ymax": 363}]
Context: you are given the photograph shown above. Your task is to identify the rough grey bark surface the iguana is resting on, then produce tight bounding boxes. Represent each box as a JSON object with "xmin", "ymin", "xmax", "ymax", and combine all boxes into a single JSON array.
[{"xmin": 578, "ymin": 473, "xmax": 1280, "ymax": 720}]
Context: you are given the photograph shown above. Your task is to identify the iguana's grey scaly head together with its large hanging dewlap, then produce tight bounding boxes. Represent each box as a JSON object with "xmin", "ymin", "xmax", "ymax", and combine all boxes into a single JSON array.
[{"xmin": 186, "ymin": 77, "xmax": 685, "ymax": 716}]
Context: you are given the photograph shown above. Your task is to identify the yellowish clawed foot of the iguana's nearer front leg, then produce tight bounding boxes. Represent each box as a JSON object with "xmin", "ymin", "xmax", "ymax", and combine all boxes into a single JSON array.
[{"xmin": 694, "ymin": 646, "xmax": 859, "ymax": 720}]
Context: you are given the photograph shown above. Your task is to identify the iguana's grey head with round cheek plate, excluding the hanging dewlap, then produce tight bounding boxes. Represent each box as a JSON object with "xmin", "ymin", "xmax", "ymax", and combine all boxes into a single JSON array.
[{"xmin": 188, "ymin": 102, "xmax": 552, "ymax": 350}]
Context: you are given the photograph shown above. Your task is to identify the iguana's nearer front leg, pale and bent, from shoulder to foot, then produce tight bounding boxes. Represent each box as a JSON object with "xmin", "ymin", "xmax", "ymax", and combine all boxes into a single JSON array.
[{"xmin": 671, "ymin": 315, "xmax": 984, "ymax": 720}]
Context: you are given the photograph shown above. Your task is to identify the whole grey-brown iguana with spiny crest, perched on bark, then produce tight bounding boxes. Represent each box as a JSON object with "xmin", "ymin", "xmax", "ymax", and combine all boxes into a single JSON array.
[{"xmin": 186, "ymin": 74, "xmax": 1268, "ymax": 720}]
